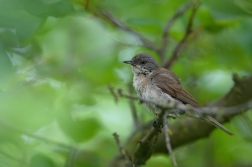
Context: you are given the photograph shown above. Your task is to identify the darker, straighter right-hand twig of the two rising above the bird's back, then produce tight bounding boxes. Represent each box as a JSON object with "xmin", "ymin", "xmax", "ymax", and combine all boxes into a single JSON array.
[{"xmin": 164, "ymin": 2, "xmax": 200, "ymax": 69}]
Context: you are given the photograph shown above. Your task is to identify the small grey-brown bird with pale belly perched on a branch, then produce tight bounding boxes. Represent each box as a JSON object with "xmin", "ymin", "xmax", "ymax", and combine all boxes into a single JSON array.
[{"xmin": 123, "ymin": 53, "xmax": 233, "ymax": 136}]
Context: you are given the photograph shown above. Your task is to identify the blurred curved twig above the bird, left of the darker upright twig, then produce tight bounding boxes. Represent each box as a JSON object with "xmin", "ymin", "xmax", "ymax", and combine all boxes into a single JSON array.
[{"xmin": 159, "ymin": 2, "xmax": 193, "ymax": 62}]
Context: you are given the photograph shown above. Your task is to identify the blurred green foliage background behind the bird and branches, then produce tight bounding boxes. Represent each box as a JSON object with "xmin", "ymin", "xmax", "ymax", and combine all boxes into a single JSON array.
[{"xmin": 0, "ymin": 0, "xmax": 252, "ymax": 167}]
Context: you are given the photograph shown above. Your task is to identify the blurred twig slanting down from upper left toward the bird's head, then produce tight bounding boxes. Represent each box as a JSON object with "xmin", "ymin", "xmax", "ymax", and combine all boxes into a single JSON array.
[{"xmin": 98, "ymin": 8, "xmax": 158, "ymax": 52}]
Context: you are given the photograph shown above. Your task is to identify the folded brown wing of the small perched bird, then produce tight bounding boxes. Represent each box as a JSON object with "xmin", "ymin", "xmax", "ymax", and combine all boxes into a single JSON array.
[{"xmin": 151, "ymin": 68, "xmax": 199, "ymax": 107}]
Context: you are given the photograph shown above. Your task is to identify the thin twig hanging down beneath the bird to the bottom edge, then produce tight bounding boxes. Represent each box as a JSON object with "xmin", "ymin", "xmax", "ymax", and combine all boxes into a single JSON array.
[{"xmin": 163, "ymin": 113, "xmax": 177, "ymax": 166}]
